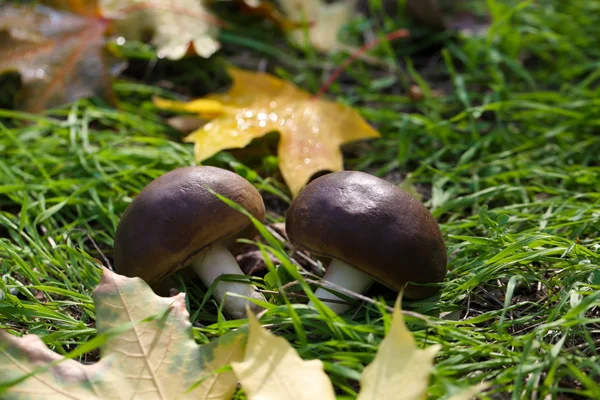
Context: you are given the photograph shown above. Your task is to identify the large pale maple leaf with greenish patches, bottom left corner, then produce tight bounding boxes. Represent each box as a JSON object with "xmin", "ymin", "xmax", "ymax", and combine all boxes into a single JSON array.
[{"xmin": 0, "ymin": 269, "xmax": 245, "ymax": 400}]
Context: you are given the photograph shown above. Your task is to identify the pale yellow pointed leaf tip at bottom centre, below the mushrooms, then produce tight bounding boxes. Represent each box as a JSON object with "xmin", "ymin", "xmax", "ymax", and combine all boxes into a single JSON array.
[{"xmin": 231, "ymin": 311, "xmax": 335, "ymax": 400}]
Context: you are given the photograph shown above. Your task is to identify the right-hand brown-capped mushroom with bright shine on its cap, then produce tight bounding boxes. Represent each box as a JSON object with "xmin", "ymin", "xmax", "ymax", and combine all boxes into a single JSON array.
[{"xmin": 286, "ymin": 171, "xmax": 447, "ymax": 314}]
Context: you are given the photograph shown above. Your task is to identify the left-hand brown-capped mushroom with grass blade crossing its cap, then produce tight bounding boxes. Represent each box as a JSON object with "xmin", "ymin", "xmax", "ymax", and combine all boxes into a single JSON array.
[{"xmin": 114, "ymin": 166, "xmax": 265, "ymax": 318}]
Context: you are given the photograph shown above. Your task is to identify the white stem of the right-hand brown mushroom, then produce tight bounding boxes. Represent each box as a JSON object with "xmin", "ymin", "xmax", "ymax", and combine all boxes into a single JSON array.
[{"xmin": 308, "ymin": 259, "xmax": 373, "ymax": 314}]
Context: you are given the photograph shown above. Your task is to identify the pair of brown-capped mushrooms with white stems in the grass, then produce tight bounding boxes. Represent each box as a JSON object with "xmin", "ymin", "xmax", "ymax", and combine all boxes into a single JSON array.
[{"xmin": 114, "ymin": 166, "xmax": 446, "ymax": 318}]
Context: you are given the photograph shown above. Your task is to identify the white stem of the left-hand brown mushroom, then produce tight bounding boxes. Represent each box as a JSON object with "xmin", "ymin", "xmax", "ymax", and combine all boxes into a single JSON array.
[{"xmin": 191, "ymin": 244, "xmax": 266, "ymax": 319}]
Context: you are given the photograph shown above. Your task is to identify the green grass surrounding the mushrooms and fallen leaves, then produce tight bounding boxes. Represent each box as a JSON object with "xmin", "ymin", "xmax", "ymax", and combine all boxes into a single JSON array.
[{"xmin": 0, "ymin": 0, "xmax": 600, "ymax": 399}]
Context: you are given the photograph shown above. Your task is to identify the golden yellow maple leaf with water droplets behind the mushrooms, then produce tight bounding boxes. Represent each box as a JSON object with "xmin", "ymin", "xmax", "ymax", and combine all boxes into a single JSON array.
[{"xmin": 154, "ymin": 68, "xmax": 379, "ymax": 197}]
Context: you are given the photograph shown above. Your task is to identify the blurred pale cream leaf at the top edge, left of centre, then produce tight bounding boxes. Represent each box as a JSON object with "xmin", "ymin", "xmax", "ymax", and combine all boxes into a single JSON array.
[{"xmin": 97, "ymin": 0, "xmax": 220, "ymax": 59}]
